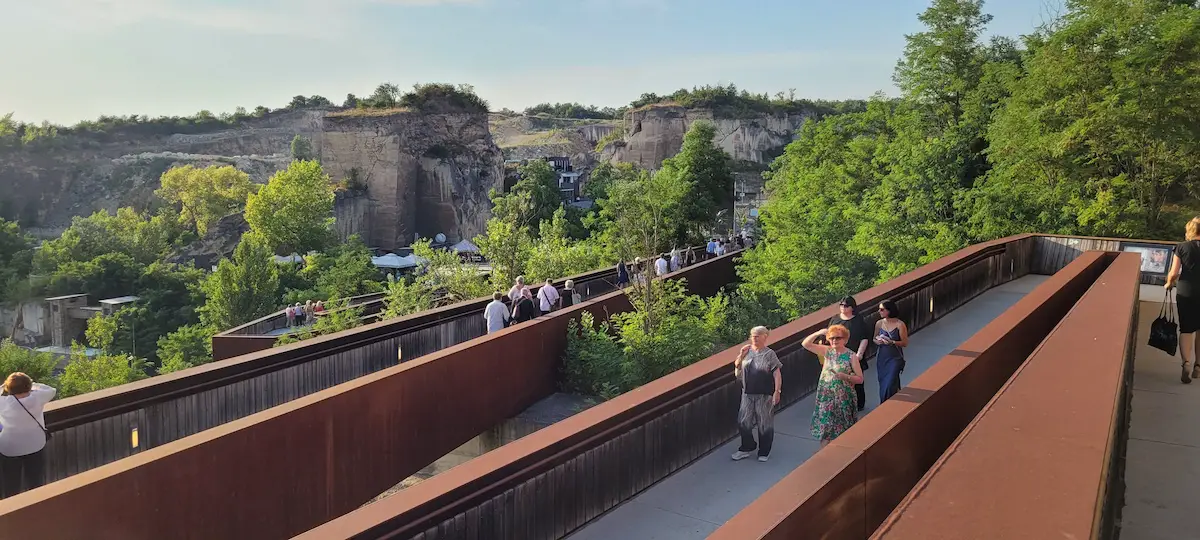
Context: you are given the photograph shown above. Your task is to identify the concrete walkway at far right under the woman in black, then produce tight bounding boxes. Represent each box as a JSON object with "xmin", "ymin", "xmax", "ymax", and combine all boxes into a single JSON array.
[{"xmin": 1121, "ymin": 286, "xmax": 1200, "ymax": 540}]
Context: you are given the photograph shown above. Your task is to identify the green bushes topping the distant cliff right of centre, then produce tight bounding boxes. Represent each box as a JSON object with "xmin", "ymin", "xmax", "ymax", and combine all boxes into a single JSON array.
[{"xmin": 629, "ymin": 84, "xmax": 866, "ymax": 118}]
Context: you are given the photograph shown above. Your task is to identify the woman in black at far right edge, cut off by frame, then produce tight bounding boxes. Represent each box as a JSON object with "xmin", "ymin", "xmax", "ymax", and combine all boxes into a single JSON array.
[{"xmin": 1165, "ymin": 217, "xmax": 1200, "ymax": 384}]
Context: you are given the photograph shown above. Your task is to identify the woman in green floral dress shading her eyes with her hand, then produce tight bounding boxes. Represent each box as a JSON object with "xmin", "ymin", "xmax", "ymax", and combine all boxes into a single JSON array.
[{"xmin": 803, "ymin": 324, "xmax": 863, "ymax": 448}]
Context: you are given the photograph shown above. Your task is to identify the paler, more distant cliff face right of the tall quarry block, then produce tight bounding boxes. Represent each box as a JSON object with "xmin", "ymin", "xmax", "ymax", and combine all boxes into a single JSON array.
[{"xmin": 602, "ymin": 104, "xmax": 815, "ymax": 169}]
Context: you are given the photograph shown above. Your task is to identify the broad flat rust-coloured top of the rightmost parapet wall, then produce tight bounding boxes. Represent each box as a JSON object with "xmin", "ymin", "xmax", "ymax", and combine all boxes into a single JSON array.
[{"xmin": 871, "ymin": 253, "xmax": 1141, "ymax": 540}]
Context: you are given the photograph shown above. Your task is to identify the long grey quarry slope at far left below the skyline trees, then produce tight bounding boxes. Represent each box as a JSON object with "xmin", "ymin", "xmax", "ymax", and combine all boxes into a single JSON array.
[{"xmin": 0, "ymin": 109, "xmax": 325, "ymax": 236}]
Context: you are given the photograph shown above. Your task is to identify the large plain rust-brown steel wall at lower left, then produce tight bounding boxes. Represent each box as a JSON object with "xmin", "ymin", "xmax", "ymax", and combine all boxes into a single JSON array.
[{"xmin": 0, "ymin": 257, "xmax": 736, "ymax": 540}]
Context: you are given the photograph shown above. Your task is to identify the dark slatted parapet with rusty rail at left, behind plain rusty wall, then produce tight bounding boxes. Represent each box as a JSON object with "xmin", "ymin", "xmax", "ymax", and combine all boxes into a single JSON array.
[{"xmin": 30, "ymin": 252, "xmax": 740, "ymax": 492}]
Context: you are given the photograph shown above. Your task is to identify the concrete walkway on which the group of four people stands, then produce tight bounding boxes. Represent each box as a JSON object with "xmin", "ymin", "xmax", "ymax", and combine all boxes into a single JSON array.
[{"xmin": 570, "ymin": 276, "xmax": 1046, "ymax": 540}]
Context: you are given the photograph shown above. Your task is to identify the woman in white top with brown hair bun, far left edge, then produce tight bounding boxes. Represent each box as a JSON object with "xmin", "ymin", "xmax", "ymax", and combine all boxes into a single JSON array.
[{"xmin": 0, "ymin": 371, "xmax": 58, "ymax": 498}]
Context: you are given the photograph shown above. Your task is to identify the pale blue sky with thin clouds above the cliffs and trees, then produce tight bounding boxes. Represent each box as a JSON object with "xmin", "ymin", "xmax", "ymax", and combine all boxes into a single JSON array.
[{"xmin": 0, "ymin": 0, "xmax": 1061, "ymax": 124}]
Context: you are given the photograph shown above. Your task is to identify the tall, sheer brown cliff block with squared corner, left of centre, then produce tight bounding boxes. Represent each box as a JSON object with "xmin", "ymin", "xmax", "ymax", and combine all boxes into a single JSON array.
[{"xmin": 318, "ymin": 112, "xmax": 504, "ymax": 250}]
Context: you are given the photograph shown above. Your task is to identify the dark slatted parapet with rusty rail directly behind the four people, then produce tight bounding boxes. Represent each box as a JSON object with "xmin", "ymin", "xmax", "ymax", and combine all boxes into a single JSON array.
[{"xmin": 292, "ymin": 236, "xmax": 1033, "ymax": 540}]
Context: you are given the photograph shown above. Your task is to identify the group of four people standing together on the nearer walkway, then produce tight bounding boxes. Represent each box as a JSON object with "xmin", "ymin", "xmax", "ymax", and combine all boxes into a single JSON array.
[{"xmin": 732, "ymin": 296, "xmax": 908, "ymax": 461}]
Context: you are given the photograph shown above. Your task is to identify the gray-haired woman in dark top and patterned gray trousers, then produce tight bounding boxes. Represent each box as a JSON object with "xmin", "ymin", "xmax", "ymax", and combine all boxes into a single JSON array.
[{"xmin": 733, "ymin": 326, "xmax": 784, "ymax": 461}]
